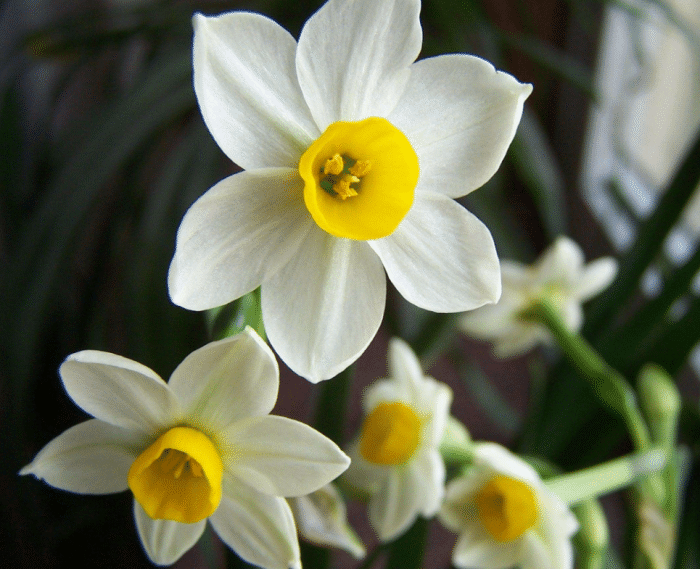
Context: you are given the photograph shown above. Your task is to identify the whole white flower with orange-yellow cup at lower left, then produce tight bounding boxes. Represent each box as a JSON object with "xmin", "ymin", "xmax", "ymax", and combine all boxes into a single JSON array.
[{"xmin": 20, "ymin": 328, "xmax": 349, "ymax": 569}]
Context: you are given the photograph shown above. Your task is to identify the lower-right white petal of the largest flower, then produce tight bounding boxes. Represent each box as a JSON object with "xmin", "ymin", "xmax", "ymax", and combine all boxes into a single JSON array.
[{"xmin": 369, "ymin": 193, "xmax": 501, "ymax": 312}]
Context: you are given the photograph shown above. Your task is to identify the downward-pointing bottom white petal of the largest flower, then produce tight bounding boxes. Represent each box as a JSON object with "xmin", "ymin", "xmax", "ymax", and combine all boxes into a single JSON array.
[{"xmin": 262, "ymin": 227, "xmax": 386, "ymax": 383}]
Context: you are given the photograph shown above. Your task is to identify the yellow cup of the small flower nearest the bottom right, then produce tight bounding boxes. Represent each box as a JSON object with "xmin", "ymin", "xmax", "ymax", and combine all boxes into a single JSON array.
[{"xmin": 476, "ymin": 475, "xmax": 537, "ymax": 542}]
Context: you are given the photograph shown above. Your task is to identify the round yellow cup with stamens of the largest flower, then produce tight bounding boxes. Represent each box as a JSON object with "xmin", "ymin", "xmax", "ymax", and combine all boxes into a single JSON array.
[{"xmin": 299, "ymin": 117, "xmax": 419, "ymax": 240}]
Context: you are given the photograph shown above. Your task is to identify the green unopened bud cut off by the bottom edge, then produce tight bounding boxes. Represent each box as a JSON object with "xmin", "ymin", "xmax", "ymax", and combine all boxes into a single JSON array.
[{"xmin": 573, "ymin": 499, "xmax": 610, "ymax": 569}]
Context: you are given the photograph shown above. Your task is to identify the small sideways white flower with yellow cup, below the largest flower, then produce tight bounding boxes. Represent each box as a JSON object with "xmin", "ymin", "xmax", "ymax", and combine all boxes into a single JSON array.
[{"xmin": 345, "ymin": 338, "xmax": 452, "ymax": 541}]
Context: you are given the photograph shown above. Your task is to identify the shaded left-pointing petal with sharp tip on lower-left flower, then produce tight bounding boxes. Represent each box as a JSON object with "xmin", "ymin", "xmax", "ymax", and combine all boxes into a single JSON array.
[{"xmin": 19, "ymin": 419, "xmax": 146, "ymax": 494}]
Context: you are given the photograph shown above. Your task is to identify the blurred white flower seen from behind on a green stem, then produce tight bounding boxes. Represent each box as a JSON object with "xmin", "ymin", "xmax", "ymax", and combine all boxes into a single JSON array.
[{"xmin": 458, "ymin": 236, "xmax": 617, "ymax": 358}]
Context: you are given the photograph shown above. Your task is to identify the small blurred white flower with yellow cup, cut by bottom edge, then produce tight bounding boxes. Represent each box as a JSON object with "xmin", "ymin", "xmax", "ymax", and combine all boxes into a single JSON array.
[{"xmin": 438, "ymin": 443, "xmax": 578, "ymax": 569}]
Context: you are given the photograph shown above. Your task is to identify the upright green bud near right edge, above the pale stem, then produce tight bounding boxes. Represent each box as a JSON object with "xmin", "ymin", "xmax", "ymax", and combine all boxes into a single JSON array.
[{"xmin": 637, "ymin": 364, "xmax": 681, "ymax": 447}]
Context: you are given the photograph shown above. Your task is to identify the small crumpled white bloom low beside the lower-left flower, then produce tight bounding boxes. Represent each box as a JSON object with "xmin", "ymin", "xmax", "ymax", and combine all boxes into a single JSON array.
[{"xmin": 289, "ymin": 484, "xmax": 366, "ymax": 559}]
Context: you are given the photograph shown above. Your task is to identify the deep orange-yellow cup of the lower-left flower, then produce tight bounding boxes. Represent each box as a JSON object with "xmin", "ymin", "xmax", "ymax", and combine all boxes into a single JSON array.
[{"xmin": 128, "ymin": 427, "xmax": 223, "ymax": 524}]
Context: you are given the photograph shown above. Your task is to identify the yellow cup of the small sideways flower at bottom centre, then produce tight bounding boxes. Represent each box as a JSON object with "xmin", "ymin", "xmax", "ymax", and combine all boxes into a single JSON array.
[{"xmin": 360, "ymin": 401, "xmax": 421, "ymax": 465}]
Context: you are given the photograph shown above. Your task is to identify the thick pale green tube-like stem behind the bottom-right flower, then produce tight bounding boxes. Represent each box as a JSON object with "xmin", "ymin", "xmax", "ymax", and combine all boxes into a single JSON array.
[{"xmin": 545, "ymin": 448, "xmax": 668, "ymax": 505}]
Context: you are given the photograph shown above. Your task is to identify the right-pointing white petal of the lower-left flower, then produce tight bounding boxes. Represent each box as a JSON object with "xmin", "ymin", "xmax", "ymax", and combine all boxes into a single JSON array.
[{"xmin": 221, "ymin": 415, "xmax": 350, "ymax": 496}]
